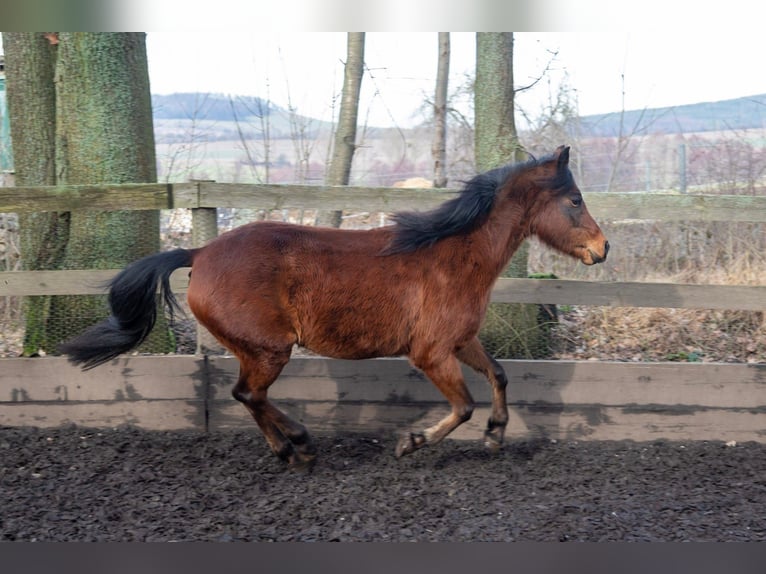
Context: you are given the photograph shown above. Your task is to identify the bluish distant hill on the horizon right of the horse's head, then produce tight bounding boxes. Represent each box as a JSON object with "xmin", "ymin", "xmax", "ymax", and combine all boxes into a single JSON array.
[{"xmin": 580, "ymin": 94, "xmax": 766, "ymax": 137}]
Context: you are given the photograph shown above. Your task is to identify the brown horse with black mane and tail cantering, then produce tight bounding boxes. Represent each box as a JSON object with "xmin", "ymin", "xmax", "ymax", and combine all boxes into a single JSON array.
[{"xmin": 60, "ymin": 146, "xmax": 609, "ymax": 467}]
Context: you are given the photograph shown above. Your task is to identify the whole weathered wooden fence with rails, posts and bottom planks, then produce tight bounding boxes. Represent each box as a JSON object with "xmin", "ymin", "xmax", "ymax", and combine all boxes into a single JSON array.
[{"xmin": 0, "ymin": 182, "xmax": 766, "ymax": 442}]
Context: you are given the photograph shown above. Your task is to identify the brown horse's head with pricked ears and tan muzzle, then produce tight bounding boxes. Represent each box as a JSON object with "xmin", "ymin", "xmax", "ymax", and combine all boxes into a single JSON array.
[{"xmin": 528, "ymin": 146, "xmax": 609, "ymax": 265}]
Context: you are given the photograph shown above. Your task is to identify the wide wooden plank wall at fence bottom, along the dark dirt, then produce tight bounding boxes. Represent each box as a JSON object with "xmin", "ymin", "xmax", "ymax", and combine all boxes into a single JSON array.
[{"xmin": 0, "ymin": 355, "xmax": 766, "ymax": 442}]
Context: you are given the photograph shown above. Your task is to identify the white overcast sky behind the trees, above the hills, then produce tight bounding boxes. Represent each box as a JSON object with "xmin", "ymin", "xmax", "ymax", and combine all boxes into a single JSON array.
[{"xmin": 147, "ymin": 29, "xmax": 766, "ymax": 127}]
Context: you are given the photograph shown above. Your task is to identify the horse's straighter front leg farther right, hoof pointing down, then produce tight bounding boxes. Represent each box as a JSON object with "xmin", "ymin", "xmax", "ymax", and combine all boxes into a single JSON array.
[{"xmin": 457, "ymin": 337, "xmax": 508, "ymax": 449}]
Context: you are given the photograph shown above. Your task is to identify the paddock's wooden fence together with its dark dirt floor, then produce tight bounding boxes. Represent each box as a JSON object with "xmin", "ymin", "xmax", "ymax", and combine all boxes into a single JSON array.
[{"xmin": 0, "ymin": 182, "xmax": 766, "ymax": 542}]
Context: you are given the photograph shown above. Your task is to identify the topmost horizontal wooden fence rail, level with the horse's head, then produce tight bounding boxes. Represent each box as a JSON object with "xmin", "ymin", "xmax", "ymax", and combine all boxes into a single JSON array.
[{"xmin": 0, "ymin": 182, "xmax": 766, "ymax": 222}]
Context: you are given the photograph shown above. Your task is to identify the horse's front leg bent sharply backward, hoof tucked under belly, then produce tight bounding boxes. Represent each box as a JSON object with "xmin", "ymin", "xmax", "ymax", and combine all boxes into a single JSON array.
[{"xmin": 396, "ymin": 355, "xmax": 473, "ymax": 458}]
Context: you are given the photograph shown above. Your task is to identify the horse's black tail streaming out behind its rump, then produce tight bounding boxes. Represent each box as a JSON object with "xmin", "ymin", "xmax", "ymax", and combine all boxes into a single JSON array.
[{"xmin": 58, "ymin": 249, "xmax": 194, "ymax": 369}]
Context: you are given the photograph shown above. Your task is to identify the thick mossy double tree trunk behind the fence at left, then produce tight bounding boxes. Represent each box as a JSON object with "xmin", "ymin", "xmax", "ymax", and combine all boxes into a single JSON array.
[{"xmin": 6, "ymin": 32, "xmax": 169, "ymax": 354}]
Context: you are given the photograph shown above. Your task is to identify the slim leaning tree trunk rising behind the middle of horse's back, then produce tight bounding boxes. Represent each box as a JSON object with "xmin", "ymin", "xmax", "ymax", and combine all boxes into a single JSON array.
[{"xmin": 316, "ymin": 32, "xmax": 365, "ymax": 227}]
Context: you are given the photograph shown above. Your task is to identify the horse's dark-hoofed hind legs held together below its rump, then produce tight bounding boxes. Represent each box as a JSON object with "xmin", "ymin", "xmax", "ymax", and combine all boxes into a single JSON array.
[{"xmin": 232, "ymin": 350, "xmax": 316, "ymax": 470}]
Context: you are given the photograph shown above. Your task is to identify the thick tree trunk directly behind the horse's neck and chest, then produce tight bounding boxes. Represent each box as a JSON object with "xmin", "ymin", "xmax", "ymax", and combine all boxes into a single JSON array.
[{"xmin": 474, "ymin": 32, "xmax": 550, "ymax": 358}]
